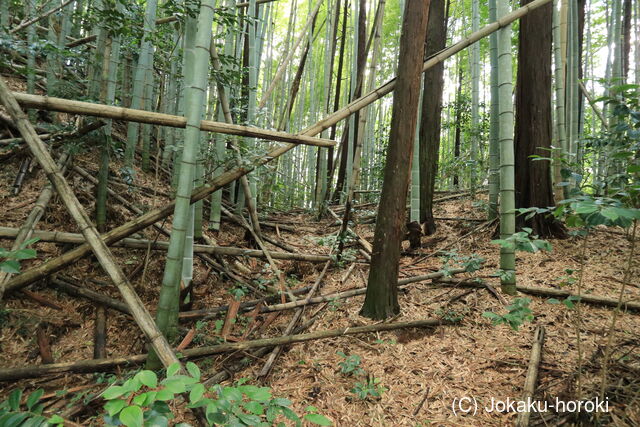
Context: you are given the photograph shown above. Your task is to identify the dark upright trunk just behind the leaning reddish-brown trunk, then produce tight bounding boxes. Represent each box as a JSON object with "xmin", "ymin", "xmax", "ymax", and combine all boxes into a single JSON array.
[{"xmin": 418, "ymin": 0, "xmax": 449, "ymax": 236}]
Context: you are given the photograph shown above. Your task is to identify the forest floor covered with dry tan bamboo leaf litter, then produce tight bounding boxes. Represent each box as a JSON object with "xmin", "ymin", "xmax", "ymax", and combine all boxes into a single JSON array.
[{"xmin": 0, "ymin": 145, "xmax": 640, "ymax": 426}]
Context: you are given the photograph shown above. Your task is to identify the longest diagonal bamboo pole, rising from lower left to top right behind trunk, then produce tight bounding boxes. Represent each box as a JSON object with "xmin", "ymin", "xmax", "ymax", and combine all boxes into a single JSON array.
[{"xmin": 6, "ymin": 0, "xmax": 550, "ymax": 298}]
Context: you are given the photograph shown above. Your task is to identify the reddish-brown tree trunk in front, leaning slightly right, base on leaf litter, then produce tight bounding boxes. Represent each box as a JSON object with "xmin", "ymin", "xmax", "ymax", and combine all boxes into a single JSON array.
[{"xmin": 360, "ymin": 0, "xmax": 430, "ymax": 319}]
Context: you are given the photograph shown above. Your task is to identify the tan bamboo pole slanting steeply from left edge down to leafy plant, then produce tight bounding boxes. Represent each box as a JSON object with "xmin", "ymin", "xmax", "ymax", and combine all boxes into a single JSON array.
[{"xmin": 0, "ymin": 79, "xmax": 179, "ymax": 372}]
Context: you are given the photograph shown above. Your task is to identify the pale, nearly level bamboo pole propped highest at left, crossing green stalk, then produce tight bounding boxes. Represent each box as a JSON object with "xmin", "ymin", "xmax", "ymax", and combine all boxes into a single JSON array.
[{"xmin": 13, "ymin": 92, "xmax": 336, "ymax": 147}]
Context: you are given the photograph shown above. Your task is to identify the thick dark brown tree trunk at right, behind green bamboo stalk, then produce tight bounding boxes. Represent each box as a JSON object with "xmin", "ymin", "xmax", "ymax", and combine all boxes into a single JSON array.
[{"xmin": 515, "ymin": 0, "xmax": 565, "ymax": 237}]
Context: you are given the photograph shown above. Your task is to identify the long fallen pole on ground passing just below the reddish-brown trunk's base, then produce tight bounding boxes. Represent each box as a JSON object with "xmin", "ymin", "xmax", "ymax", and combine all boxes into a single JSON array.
[{"xmin": 0, "ymin": 319, "xmax": 455, "ymax": 381}]
